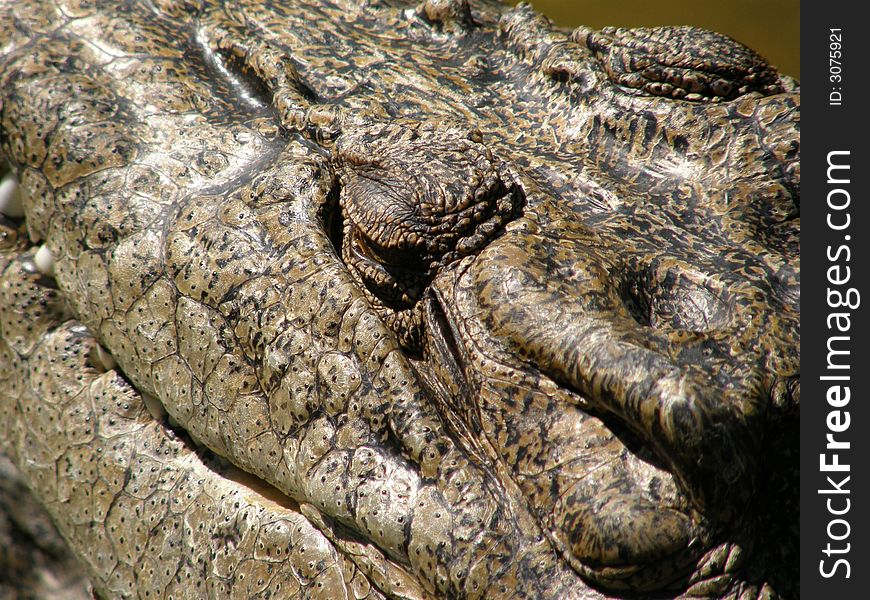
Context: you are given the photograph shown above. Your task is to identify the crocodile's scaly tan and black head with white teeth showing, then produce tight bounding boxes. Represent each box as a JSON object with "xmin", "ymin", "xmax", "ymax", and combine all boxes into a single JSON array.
[{"xmin": 0, "ymin": 0, "xmax": 800, "ymax": 599}]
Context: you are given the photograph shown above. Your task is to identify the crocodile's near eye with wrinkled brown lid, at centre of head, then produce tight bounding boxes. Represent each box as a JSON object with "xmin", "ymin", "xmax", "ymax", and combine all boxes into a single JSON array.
[{"xmin": 336, "ymin": 119, "xmax": 524, "ymax": 347}]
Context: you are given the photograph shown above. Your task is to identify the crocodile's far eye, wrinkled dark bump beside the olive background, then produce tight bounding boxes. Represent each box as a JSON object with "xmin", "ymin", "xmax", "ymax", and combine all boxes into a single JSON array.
[{"xmin": 571, "ymin": 27, "xmax": 784, "ymax": 102}]
